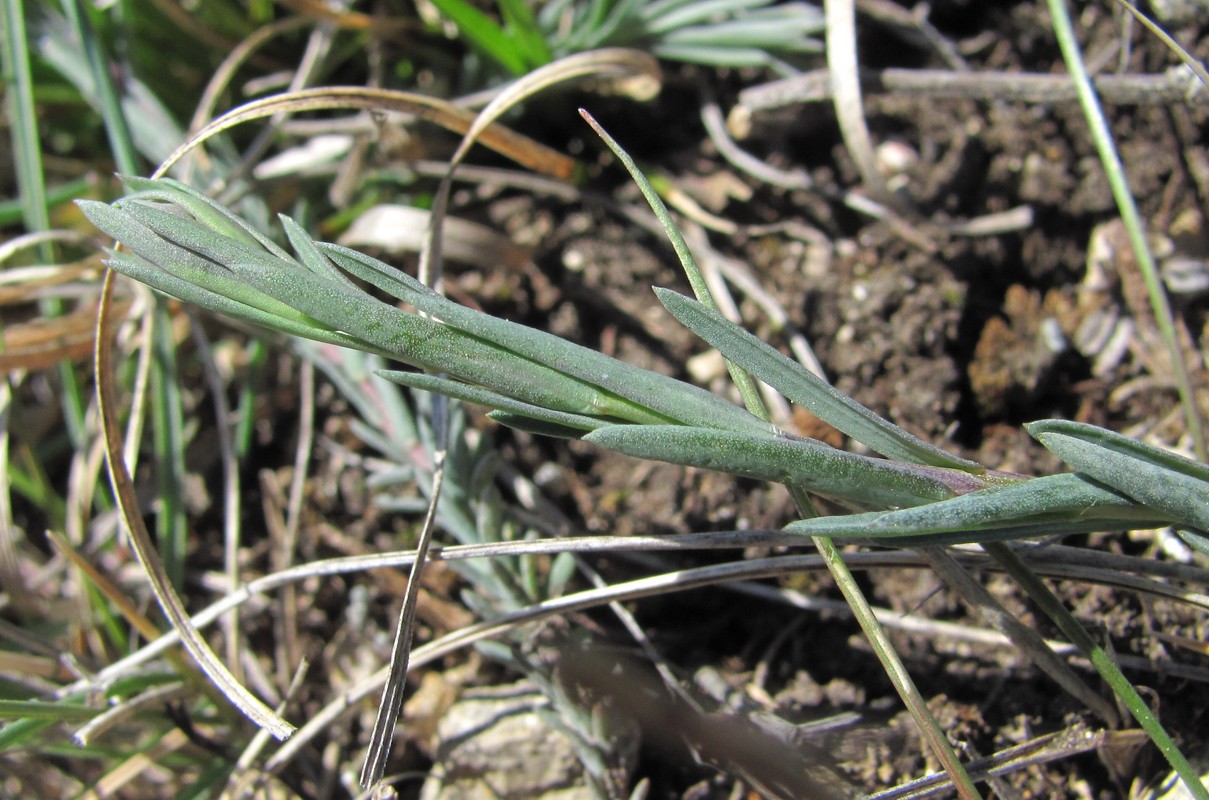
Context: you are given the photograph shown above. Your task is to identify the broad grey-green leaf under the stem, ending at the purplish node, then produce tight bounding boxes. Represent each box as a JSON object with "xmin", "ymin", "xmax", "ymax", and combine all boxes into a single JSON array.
[{"xmin": 584, "ymin": 425, "xmax": 962, "ymax": 508}]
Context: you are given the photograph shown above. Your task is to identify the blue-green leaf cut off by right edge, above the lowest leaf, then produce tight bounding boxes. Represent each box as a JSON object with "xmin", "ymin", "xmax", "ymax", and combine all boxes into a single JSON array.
[{"xmin": 1024, "ymin": 419, "xmax": 1209, "ymax": 532}]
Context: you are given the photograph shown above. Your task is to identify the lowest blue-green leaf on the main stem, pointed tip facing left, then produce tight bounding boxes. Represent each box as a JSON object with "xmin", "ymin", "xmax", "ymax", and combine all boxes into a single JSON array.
[{"xmin": 785, "ymin": 473, "xmax": 1170, "ymax": 547}]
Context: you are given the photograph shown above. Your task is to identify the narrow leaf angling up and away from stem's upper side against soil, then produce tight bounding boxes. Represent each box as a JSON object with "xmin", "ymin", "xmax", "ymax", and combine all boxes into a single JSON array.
[{"xmin": 654, "ymin": 288, "xmax": 987, "ymax": 475}]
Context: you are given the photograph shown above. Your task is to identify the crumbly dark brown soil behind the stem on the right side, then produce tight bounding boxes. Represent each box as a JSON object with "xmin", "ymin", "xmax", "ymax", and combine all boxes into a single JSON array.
[{"xmin": 372, "ymin": 2, "xmax": 1209, "ymax": 798}]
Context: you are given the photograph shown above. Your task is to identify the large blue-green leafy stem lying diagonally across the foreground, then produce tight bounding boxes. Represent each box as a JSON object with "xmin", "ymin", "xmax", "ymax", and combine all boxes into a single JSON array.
[{"xmin": 80, "ymin": 103, "xmax": 1209, "ymax": 798}]
